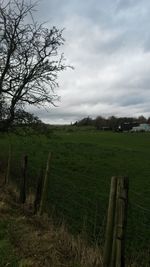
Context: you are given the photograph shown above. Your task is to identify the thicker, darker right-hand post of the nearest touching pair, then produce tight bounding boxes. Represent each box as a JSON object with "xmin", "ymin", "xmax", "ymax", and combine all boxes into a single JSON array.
[{"xmin": 115, "ymin": 177, "xmax": 129, "ymax": 267}]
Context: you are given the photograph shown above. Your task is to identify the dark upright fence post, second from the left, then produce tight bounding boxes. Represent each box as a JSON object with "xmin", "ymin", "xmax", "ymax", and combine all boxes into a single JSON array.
[{"xmin": 20, "ymin": 155, "xmax": 28, "ymax": 204}]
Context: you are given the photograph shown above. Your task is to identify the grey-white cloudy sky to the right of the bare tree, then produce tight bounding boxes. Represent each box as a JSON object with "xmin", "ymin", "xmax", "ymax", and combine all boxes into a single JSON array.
[{"xmin": 34, "ymin": 0, "xmax": 150, "ymax": 124}]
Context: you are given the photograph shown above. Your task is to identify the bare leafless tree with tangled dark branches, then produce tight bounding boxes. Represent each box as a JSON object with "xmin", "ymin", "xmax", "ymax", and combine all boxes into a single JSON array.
[{"xmin": 0, "ymin": 0, "xmax": 66, "ymax": 130}]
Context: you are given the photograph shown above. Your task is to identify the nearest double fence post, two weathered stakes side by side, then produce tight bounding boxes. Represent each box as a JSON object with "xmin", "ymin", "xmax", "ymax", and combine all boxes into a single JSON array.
[{"xmin": 104, "ymin": 177, "xmax": 129, "ymax": 267}]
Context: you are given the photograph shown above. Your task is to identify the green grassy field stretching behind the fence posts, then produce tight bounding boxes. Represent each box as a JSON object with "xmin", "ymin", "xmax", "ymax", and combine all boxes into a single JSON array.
[{"xmin": 0, "ymin": 128, "xmax": 150, "ymax": 267}]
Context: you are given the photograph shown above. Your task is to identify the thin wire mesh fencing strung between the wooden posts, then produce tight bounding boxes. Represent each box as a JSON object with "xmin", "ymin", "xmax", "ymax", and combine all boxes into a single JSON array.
[{"xmin": 0, "ymin": 148, "xmax": 150, "ymax": 267}]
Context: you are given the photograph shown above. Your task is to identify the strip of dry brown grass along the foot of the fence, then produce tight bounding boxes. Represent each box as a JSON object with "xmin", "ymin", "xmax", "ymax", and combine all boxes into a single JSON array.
[{"xmin": 0, "ymin": 185, "xmax": 102, "ymax": 267}]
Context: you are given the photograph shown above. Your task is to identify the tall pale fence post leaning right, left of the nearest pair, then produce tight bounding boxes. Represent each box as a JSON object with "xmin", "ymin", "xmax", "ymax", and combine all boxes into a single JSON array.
[{"xmin": 39, "ymin": 152, "xmax": 51, "ymax": 215}]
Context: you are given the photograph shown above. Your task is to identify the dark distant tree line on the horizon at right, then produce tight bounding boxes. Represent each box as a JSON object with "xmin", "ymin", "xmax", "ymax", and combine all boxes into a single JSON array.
[{"xmin": 74, "ymin": 115, "xmax": 150, "ymax": 131}]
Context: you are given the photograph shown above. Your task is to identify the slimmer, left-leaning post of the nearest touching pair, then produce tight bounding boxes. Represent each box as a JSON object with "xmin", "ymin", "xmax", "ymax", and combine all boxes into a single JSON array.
[{"xmin": 104, "ymin": 177, "xmax": 117, "ymax": 267}]
